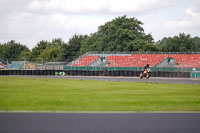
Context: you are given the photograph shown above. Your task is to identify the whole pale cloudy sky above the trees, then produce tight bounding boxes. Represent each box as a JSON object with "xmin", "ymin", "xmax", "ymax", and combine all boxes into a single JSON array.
[{"xmin": 0, "ymin": 0, "xmax": 200, "ymax": 49}]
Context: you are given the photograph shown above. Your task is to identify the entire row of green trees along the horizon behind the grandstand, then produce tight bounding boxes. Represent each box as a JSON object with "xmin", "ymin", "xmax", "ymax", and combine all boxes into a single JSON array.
[{"xmin": 0, "ymin": 16, "xmax": 200, "ymax": 62}]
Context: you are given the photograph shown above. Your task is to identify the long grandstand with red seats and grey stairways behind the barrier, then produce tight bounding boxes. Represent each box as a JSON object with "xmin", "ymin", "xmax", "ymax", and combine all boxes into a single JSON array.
[{"xmin": 67, "ymin": 52, "xmax": 200, "ymax": 70}]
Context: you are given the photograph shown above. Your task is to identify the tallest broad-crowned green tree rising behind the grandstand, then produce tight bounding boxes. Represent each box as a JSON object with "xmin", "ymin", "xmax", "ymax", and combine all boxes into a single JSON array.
[{"xmin": 81, "ymin": 16, "xmax": 158, "ymax": 54}]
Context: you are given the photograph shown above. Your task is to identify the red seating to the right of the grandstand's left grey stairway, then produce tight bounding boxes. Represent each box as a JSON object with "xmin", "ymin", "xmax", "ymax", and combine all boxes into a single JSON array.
[{"xmin": 107, "ymin": 54, "xmax": 200, "ymax": 67}]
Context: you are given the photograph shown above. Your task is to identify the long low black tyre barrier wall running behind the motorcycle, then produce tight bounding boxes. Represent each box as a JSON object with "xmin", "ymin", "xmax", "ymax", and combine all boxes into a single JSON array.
[{"xmin": 0, "ymin": 70, "xmax": 190, "ymax": 78}]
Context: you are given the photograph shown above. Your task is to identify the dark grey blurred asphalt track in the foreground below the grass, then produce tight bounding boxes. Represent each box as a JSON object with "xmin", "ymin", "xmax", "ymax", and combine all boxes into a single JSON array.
[{"xmin": 0, "ymin": 112, "xmax": 200, "ymax": 133}]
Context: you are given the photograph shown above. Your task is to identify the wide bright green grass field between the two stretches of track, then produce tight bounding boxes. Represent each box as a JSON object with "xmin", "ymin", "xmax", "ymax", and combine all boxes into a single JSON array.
[{"xmin": 0, "ymin": 76, "xmax": 200, "ymax": 111}]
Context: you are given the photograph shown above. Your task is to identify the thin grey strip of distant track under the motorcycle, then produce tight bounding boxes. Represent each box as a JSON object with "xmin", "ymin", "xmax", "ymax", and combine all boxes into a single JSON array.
[{"xmin": 9, "ymin": 76, "xmax": 200, "ymax": 84}]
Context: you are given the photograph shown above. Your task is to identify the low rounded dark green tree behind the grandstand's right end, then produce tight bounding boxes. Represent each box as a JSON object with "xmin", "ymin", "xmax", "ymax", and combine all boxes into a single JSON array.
[{"xmin": 157, "ymin": 33, "xmax": 196, "ymax": 52}]
